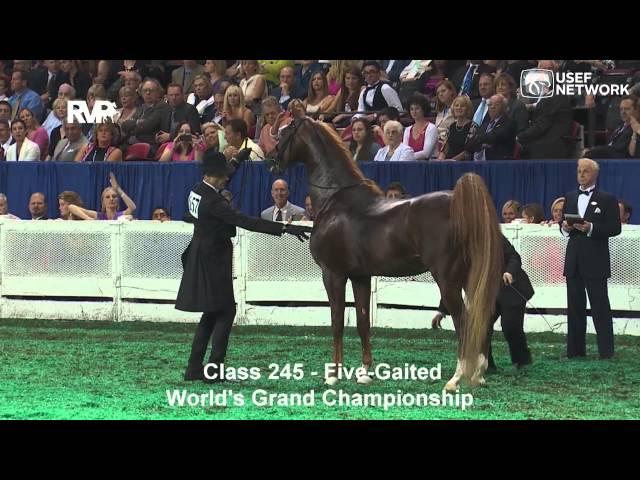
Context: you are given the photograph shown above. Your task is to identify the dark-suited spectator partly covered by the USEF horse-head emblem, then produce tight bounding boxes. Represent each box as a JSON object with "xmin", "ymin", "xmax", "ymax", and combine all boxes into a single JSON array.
[{"xmin": 516, "ymin": 60, "xmax": 573, "ymax": 160}]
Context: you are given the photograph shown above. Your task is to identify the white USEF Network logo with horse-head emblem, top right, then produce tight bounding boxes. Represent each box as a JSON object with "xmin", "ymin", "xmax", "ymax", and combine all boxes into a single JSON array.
[{"xmin": 520, "ymin": 68, "xmax": 629, "ymax": 99}]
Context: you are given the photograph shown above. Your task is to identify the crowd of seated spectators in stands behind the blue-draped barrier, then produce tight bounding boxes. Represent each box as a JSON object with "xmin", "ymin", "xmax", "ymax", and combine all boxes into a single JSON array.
[{"xmin": 0, "ymin": 60, "xmax": 640, "ymax": 223}]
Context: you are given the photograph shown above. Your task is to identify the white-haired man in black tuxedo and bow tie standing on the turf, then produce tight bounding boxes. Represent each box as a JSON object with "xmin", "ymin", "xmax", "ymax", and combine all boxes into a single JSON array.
[{"xmin": 560, "ymin": 158, "xmax": 621, "ymax": 359}]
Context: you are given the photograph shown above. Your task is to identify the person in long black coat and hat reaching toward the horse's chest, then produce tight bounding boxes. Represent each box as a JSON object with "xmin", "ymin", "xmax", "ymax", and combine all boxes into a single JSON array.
[{"xmin": 176, "ymin": 151, "xmax": 311, "ymax": 382}]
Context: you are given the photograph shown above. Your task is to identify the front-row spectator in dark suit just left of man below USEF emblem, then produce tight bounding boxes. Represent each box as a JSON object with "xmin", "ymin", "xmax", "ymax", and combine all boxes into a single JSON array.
[{"xmin": 465, "ymin": 95, "xmax": 516, "ymax": 161}]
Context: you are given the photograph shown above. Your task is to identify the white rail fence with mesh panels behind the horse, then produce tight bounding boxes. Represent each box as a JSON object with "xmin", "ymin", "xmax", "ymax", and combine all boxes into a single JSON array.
[{"xmin": 0, "ymin": 220, "xmax": 640, "ymax": 334}]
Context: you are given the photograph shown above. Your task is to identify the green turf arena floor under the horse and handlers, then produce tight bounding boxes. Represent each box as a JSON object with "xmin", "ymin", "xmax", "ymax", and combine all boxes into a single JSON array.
[{"xmin": 0, "ymin": 320, "xmax": 640, "ymax": 419}]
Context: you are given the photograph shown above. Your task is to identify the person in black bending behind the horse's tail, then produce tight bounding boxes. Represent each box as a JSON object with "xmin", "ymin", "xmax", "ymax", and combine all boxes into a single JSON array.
[{"xmin": 431, "ymin": 235, "xmax": 534, "ymax": 370}]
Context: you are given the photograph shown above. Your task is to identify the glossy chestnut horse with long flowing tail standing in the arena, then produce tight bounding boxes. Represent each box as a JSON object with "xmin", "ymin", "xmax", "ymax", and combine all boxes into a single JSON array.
[{"xmin": 267, "ymin": 118, "xmax": 503, "ymax": 391}]
